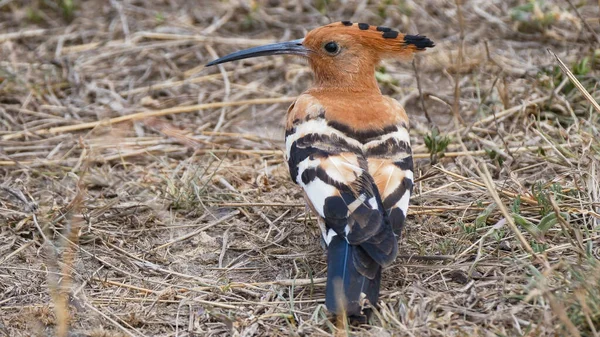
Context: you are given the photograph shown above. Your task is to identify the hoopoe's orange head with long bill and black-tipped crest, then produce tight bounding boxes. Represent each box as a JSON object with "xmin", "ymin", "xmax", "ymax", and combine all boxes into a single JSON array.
[{"xmin": 207, "ymin": 21, "xmax": 434, "ymax": 88}]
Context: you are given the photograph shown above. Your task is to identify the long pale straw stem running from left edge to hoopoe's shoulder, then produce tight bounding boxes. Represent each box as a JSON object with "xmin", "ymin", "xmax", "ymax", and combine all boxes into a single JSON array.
[{"xmin": 2, "ymin": 97, "xmax": 295, "ymax": 140}]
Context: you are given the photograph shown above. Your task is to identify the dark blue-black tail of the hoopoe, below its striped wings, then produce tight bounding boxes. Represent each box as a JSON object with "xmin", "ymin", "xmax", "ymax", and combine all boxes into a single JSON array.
[{"xmin": 325, "ymin": 235, "xmax": 381, "ymax": 317}]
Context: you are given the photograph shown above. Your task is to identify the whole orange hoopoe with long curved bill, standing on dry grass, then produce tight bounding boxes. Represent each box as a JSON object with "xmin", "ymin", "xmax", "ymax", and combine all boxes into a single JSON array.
[{"xmin": 207, "ymin": 21, "xmax": 434, "ymax": 317}]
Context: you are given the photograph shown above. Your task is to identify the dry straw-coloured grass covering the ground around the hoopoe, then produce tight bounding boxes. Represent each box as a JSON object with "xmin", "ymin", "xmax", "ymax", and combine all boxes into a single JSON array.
[{"xmin": 0, "ymin": 0, "xmax": 600, "ymax": 336}]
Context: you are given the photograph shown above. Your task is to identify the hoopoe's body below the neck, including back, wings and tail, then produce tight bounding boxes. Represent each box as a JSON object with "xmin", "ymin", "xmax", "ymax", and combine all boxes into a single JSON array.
[{"xmin": 286, "ymin": 89, "xmax": 412, "ymax": 316}]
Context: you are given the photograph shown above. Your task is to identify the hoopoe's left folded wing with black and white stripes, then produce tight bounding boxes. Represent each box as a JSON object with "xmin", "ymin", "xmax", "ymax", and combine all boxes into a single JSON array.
[{"xmin": 286, "ymin": 115, "xmax": 397, "ymax": 270}]
